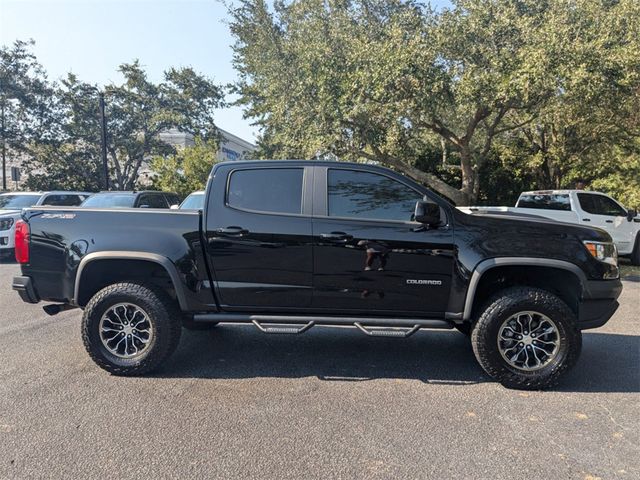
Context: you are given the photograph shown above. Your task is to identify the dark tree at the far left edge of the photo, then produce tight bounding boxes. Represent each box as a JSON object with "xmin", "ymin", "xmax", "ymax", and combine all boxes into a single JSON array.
[{"xmin": 0, "ymin": 40, "xmax": 58, "ymax": 189}]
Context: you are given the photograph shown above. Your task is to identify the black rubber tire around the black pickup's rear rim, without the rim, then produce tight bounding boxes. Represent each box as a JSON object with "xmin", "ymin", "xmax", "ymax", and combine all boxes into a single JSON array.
[{"xmin": 82, "ymin": 283, "xmax": 182, "ymax": 376}]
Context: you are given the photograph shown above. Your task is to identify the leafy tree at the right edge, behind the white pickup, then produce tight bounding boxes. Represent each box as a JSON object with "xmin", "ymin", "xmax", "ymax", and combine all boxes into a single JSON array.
[{"xmin": 501, "ymin": 0, "xmax": 640, "ymax": 196}]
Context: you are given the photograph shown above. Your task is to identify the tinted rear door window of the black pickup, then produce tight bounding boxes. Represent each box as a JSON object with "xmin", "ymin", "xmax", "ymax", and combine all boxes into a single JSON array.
[{"xmin": 227, "ymin": 168, "xmax": 303, "ymax": 214}]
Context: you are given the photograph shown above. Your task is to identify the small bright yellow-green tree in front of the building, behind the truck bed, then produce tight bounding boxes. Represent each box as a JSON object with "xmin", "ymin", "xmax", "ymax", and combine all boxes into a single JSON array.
[{"xmin": 151, "ymin": 138, "xmax": 219, "ymax": 198}]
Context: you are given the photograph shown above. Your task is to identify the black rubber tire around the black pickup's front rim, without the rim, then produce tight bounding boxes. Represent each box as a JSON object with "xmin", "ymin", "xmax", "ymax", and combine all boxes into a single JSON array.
[{"xmin": 471, "ymin": 287, "xmax": 582, "ymax": 390}]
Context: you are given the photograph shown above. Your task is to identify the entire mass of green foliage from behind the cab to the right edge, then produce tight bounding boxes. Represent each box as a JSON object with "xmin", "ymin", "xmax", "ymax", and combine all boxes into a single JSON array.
[{"xmin": 231, "ymin": 0, "xmax": 640, "ymax": 204}]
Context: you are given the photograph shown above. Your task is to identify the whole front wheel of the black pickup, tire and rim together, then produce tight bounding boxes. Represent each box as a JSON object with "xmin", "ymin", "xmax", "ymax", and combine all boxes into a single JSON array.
[{"xmin": 471, "ymin": 287, "xmax": 582, "ymax": 390}]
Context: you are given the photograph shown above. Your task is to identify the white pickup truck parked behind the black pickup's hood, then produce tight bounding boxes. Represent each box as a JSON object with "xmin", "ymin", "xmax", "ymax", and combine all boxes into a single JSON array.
[{"xmin": 459, "ymin": 190, "xmax": 640, "ymax": 265}]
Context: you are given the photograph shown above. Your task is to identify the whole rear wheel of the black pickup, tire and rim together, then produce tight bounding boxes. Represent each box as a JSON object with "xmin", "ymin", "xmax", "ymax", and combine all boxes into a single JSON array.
[{"xmin": 82, "ymin": 283, "xmax": 181, "ymax": 376}]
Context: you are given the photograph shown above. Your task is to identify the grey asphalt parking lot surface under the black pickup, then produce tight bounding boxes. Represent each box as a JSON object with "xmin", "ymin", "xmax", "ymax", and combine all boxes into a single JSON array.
[{"xmin": 0, "ymin": 264, "xmax": 640, "ymax": 480}]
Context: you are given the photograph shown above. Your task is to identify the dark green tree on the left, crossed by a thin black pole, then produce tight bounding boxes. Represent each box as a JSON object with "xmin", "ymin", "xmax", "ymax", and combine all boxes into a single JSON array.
[{"xmin": 29, "ymin": 61, "xmax": 224, "ymax": 190}]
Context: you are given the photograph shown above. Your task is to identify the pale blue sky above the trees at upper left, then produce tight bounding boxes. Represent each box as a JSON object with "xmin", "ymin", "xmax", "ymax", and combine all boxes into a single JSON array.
[{"xmin": 0, "ymin": 0, "xmax": 449, "ymax": 142}]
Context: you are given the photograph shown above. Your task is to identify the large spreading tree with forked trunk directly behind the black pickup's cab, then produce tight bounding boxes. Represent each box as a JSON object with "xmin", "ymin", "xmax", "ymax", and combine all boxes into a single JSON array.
[{"xmin": 231, "ymin": 0, "xmax": 640, "ymax": 204}]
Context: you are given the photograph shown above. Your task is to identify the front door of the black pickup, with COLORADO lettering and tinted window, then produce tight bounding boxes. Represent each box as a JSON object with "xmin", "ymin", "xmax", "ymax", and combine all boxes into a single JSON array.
[{"xmin": 313, "ymin": 167, "xmax": 453, "ymax": 316}]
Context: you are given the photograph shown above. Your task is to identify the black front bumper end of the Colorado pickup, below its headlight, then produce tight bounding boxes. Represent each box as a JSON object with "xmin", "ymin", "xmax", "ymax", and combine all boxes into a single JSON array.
[{"xmin": 578, "ymin": 280, "xmax": 622, "ymax": 330}]
